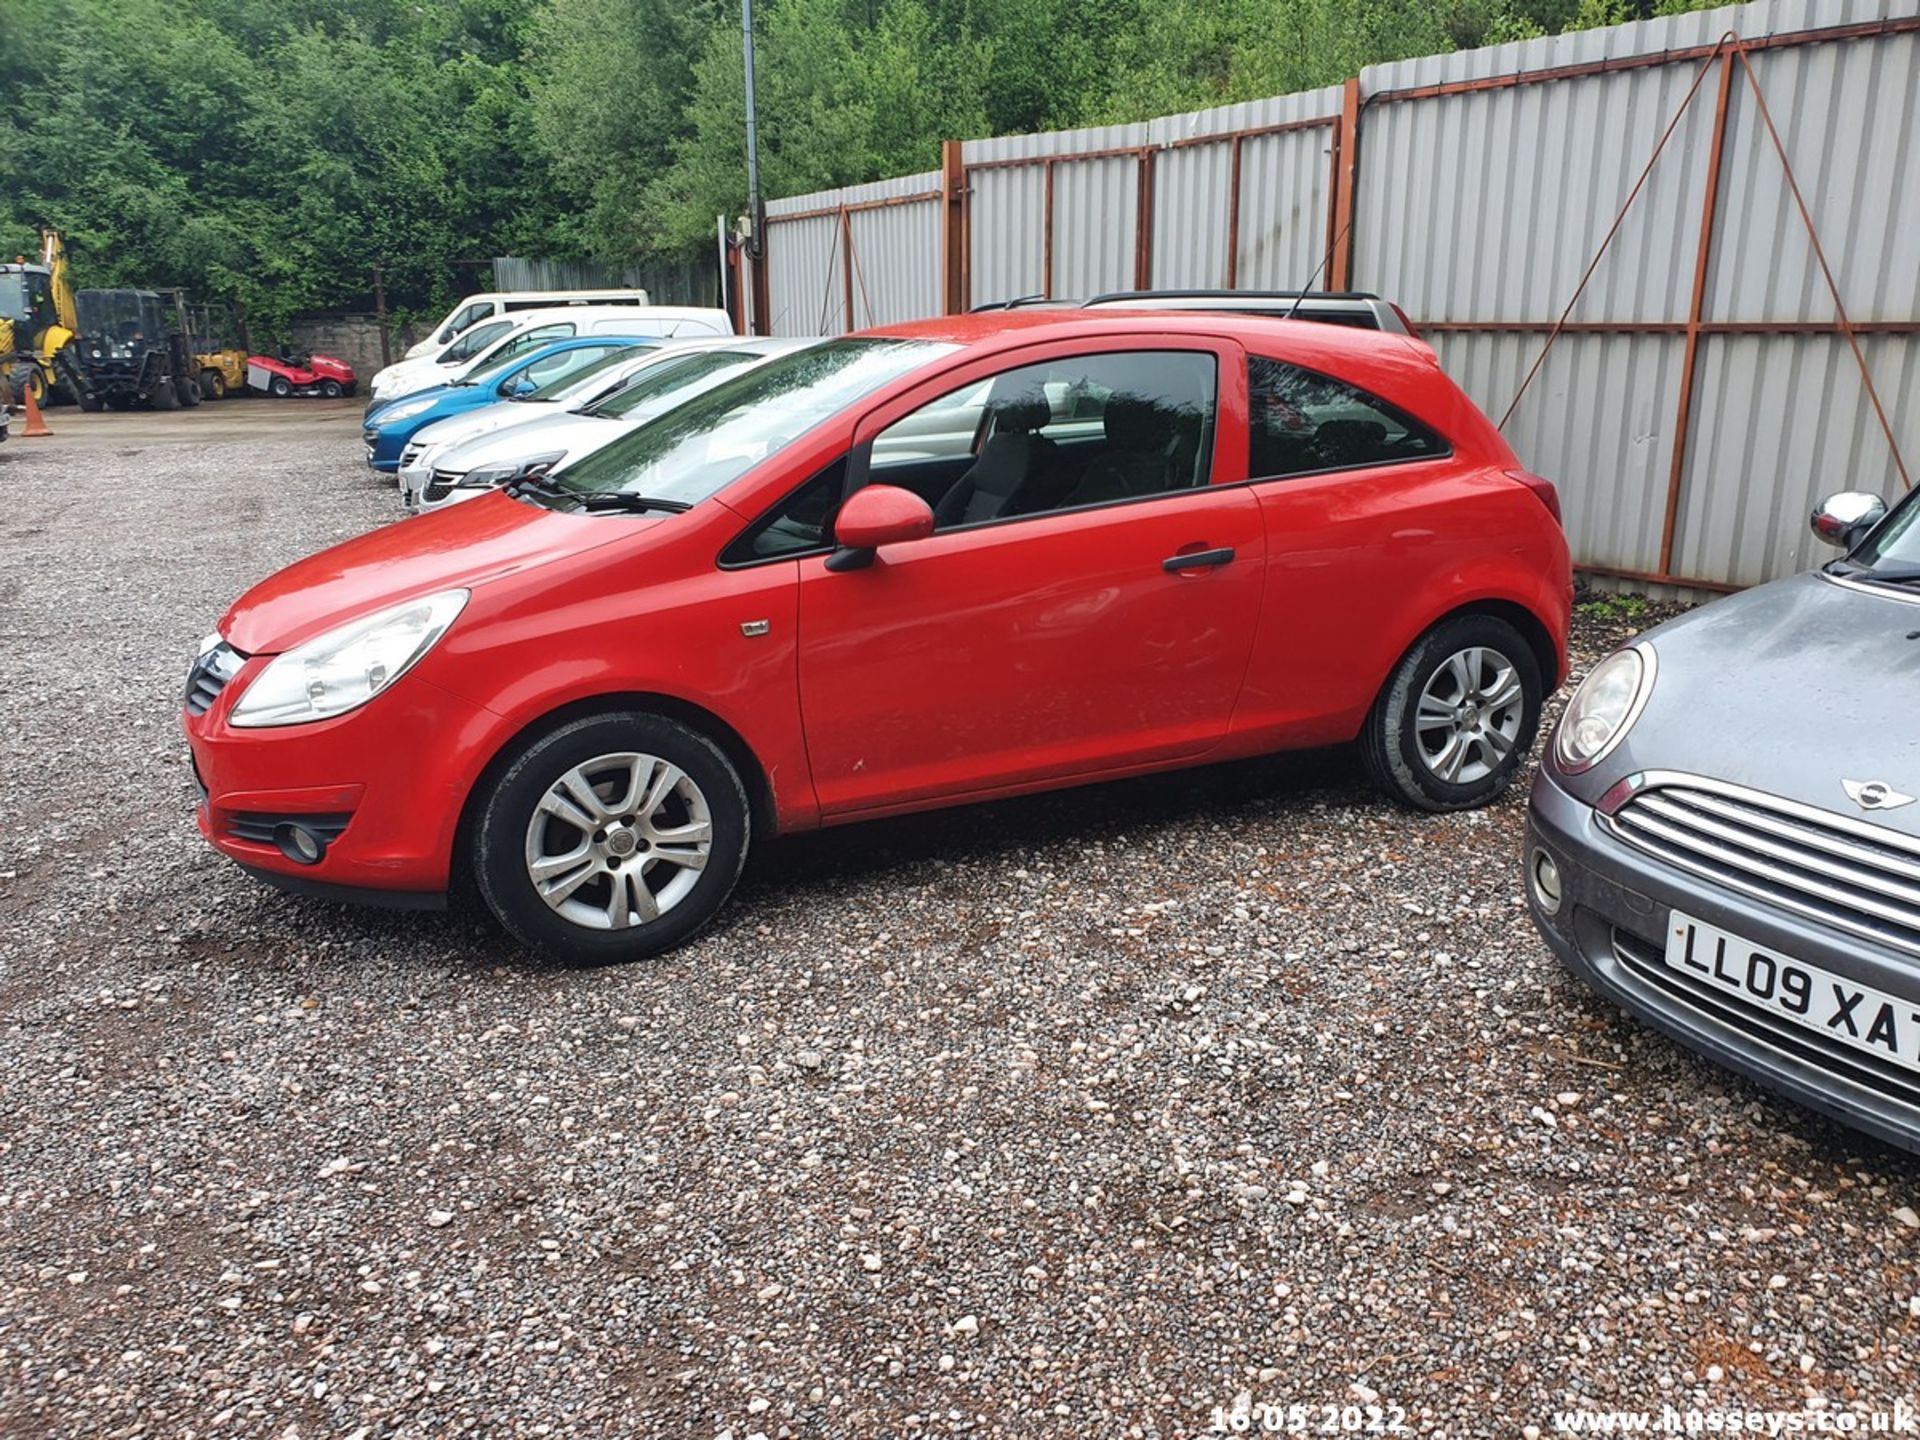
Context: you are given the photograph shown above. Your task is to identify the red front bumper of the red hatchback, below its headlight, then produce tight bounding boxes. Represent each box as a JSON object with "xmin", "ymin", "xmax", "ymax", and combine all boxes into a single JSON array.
[{"xmin": 180, "ymin": 657, "xmax": 501, "ymax": 906}]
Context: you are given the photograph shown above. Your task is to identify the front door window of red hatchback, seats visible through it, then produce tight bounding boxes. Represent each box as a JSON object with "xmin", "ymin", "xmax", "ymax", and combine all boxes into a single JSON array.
[{"xmin": 870, "ymin": 351, "xmax": 1217, "ymax": 530}]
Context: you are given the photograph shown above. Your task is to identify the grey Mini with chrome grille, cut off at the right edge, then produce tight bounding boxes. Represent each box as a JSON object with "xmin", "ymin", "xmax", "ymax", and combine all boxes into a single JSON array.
[{"xmin": 1524, "ymin": 490, "xmax": 1920, "ymax": 1150}]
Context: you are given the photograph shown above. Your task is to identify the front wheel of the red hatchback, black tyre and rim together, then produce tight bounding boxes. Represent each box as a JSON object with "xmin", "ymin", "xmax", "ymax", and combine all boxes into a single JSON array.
[{"xmin": 472, "ymin": 710, "xmax": 753, "ymax": 966}]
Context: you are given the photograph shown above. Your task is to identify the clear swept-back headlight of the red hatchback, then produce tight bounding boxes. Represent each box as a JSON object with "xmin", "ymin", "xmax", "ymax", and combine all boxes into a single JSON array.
[{"xmin": 227, "ymin": 589, "xmax": 468, "ymax": 726}]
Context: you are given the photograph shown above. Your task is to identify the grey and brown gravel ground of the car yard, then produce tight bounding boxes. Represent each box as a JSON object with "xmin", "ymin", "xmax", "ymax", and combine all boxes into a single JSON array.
[{"xmin": 0, "ymin": 405, "xmax": 1920, "ymax": 1440}]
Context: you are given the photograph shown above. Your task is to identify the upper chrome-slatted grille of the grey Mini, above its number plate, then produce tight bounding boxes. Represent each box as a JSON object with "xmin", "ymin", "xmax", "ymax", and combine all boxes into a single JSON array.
[{"xmin": 1607, "ymin": 780, "xmax": 1920, "ymax": 954}]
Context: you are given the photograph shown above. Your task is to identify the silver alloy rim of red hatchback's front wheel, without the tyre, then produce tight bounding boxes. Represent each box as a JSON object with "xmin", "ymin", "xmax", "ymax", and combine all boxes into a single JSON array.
[{"xmin": 526, "ymin": 753, "xmax": 712, "ymax": 929}]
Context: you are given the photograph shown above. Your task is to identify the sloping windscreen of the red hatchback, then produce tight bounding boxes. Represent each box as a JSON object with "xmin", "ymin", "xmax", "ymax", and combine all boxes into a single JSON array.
[{"xmin": 555, "ymin": 340, "xmax": 956, "ymax": 505}]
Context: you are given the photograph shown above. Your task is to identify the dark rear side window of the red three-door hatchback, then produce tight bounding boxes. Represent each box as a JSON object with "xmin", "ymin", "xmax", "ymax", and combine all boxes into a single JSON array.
[{"xmin": 1246, "ymin": 355, "xmax": 1448, "ymax": 480}]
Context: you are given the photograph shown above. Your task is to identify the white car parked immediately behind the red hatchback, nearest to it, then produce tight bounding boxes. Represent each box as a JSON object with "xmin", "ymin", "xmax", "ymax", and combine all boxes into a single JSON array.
[{"xmin": 401, "ymin": 340, "xmax": 820, "ymax": 515}]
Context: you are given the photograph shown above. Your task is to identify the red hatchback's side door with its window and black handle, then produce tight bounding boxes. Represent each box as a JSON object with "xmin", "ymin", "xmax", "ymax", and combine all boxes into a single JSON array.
[{"xmin": 799, "ymin": 336, "xmax": 1263, "ymax": 816}]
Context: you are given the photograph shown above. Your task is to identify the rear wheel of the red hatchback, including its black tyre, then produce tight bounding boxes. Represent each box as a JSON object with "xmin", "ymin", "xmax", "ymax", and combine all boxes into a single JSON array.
[{"xmin": 1359, "ymin": 614, "xmax": 1546, "ymax": 810}]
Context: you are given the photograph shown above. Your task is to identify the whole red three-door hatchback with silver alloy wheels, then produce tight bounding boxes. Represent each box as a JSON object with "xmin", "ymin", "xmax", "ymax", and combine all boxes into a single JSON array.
[{"xmin": 184, "ymin": 311, "xmax": 1572, "ymax": 960}]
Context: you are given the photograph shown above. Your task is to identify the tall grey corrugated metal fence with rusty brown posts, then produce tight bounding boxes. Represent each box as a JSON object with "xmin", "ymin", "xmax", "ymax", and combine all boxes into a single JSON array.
[{"xmin": 748, "ymin": 0, "xmax": 1920, "ymax": 588}]
